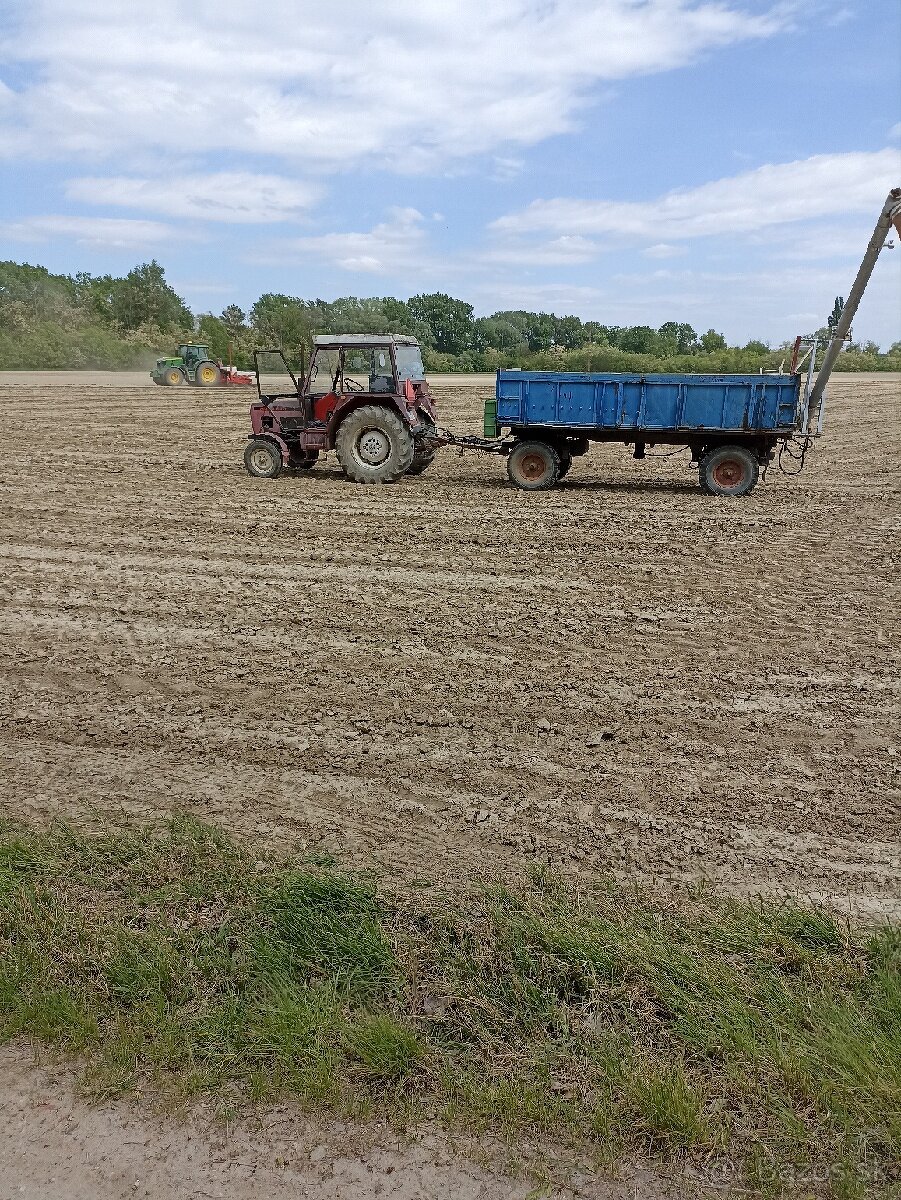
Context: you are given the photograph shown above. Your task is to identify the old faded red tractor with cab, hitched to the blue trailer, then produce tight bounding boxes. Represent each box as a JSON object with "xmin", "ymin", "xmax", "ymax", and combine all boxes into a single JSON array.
[{"xmin": 244, "ymin": 334, "xmax": 440, "ymax": 484}]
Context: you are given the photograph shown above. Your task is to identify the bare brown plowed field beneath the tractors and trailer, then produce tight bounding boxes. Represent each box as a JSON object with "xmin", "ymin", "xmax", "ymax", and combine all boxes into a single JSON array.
[{"xmin": 0, "ymin": 374, "xmax": 901, "ymax": 913}]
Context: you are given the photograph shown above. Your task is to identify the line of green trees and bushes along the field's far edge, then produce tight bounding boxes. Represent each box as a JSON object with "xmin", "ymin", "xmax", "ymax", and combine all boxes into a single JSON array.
[{"xmin": 0, "ymin": 260, "xmax": 901, "ymax": 371}]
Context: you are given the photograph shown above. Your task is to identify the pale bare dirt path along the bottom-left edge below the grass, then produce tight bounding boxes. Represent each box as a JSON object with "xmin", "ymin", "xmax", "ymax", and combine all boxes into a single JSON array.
[{"xmin": 0, "ymin": 1046, "xmax": 684, "ymax": 1200}]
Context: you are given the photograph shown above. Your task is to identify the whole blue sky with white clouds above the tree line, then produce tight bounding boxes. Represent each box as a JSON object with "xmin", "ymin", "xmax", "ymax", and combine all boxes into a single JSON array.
[{"xmin": 0, "ymin": 0, "xmax": 901, "ymax": 346}]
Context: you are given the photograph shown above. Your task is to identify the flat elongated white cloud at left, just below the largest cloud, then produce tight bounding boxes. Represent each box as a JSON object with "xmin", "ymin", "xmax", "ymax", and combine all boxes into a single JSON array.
[{"xmin": 66, "ymin": 170, "xmax": 320, "ymax": 224}]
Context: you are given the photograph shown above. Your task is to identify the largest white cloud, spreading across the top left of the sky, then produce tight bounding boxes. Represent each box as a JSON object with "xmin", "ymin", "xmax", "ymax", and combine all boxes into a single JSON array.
[{"xmin": 0, "ymin": 0, "xmax": 791, "ymax": 172}]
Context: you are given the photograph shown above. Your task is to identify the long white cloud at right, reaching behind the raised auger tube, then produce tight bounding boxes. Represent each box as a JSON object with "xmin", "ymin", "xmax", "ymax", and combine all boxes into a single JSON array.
[{"xmin": 492, "ymin": 149, "xmax": 901, "ymax": 241}]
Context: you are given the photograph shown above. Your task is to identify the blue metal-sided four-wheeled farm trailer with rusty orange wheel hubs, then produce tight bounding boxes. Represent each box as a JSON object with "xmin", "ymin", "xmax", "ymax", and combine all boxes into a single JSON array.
[{"xmin": 485, "ymin": 356, "xmax": 823, "ymax": 496}]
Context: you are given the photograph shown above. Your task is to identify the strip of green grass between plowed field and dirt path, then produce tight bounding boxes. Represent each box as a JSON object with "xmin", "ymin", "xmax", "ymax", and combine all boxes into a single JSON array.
[{"xmin": 0, "ymin": 820, "xmax": 901, "ymax": 1200}]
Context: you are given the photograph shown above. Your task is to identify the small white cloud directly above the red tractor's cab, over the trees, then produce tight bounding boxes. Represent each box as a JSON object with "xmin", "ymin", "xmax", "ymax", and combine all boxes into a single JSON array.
[{"xmin": 271, "ymin": 209, "xmax": 426, "ymax": 275}]
